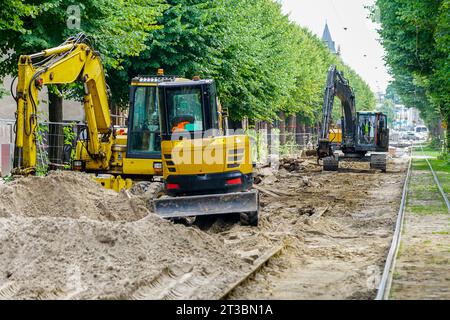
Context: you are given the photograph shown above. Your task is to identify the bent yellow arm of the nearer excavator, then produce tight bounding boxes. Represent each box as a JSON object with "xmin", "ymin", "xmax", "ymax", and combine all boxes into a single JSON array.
[{"xmin": 14, "ymin": 34, "xmax": 113, "ymax": 175}]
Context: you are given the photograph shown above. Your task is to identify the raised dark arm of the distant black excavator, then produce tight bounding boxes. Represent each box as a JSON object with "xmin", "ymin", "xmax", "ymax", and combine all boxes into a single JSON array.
[{"xmin": 317, "ymin": 65, "xmax": 356, "ymax": 159}]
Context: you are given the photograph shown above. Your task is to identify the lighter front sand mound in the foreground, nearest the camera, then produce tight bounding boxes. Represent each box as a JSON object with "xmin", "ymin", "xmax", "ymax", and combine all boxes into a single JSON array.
[{"xmin": 0, "ymin": 215, "xmax": 241, "ymax": 299}]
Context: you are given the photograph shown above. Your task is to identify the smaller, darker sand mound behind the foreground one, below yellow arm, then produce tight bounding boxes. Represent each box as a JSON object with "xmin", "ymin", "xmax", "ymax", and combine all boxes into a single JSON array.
[{"xmin": 0, "ymin": 171, "xmax": 148, "ymax": 221}]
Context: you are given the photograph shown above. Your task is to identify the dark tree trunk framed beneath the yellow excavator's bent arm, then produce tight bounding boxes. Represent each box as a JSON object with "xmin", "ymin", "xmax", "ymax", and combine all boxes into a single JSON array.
[{"xmin": 48, "ymin": 91, "xmax": 64, "ymax": 170}]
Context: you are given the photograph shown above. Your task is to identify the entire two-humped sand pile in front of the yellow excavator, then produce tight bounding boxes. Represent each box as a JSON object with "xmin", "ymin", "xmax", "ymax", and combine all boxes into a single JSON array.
[{"xmin": 0, "ymin": 172, "xmax": 245, "ymax": 299}]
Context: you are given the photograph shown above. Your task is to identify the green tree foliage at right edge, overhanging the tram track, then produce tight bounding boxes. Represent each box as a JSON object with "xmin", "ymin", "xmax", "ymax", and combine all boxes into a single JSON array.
[{"xmin": 376, "ymin": 0, "xmax": 450, "ymax": 151}]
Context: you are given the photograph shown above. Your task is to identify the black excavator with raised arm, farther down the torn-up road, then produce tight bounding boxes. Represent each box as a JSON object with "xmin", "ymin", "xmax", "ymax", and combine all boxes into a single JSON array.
[{"xmin": 317, "ymin": 65, "xmax": 389, "ymax": 172}]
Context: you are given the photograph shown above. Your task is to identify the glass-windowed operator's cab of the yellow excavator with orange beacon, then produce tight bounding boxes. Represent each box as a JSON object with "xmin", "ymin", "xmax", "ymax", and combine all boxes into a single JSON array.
[{"xmin": 123, "ymin": 74, "xmax": 219, "ymax": 176}]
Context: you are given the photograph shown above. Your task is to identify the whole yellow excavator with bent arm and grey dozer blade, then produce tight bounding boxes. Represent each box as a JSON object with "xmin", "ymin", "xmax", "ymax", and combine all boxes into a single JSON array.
[{"xmin": 14, "ymin": 34, "xmax": 259, "ymax": 225}]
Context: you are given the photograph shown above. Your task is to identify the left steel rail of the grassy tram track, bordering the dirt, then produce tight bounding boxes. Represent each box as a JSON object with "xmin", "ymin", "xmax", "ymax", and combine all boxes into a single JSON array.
[{"xmin": 375, "ymin": 150, "xmax": 412, "ymax": 300}]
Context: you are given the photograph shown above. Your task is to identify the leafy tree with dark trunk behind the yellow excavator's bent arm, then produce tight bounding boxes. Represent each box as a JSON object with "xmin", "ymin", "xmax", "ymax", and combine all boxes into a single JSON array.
[{"xmin": 0, "ymin": 0, "xmax": 163, "ymax": 168}]
